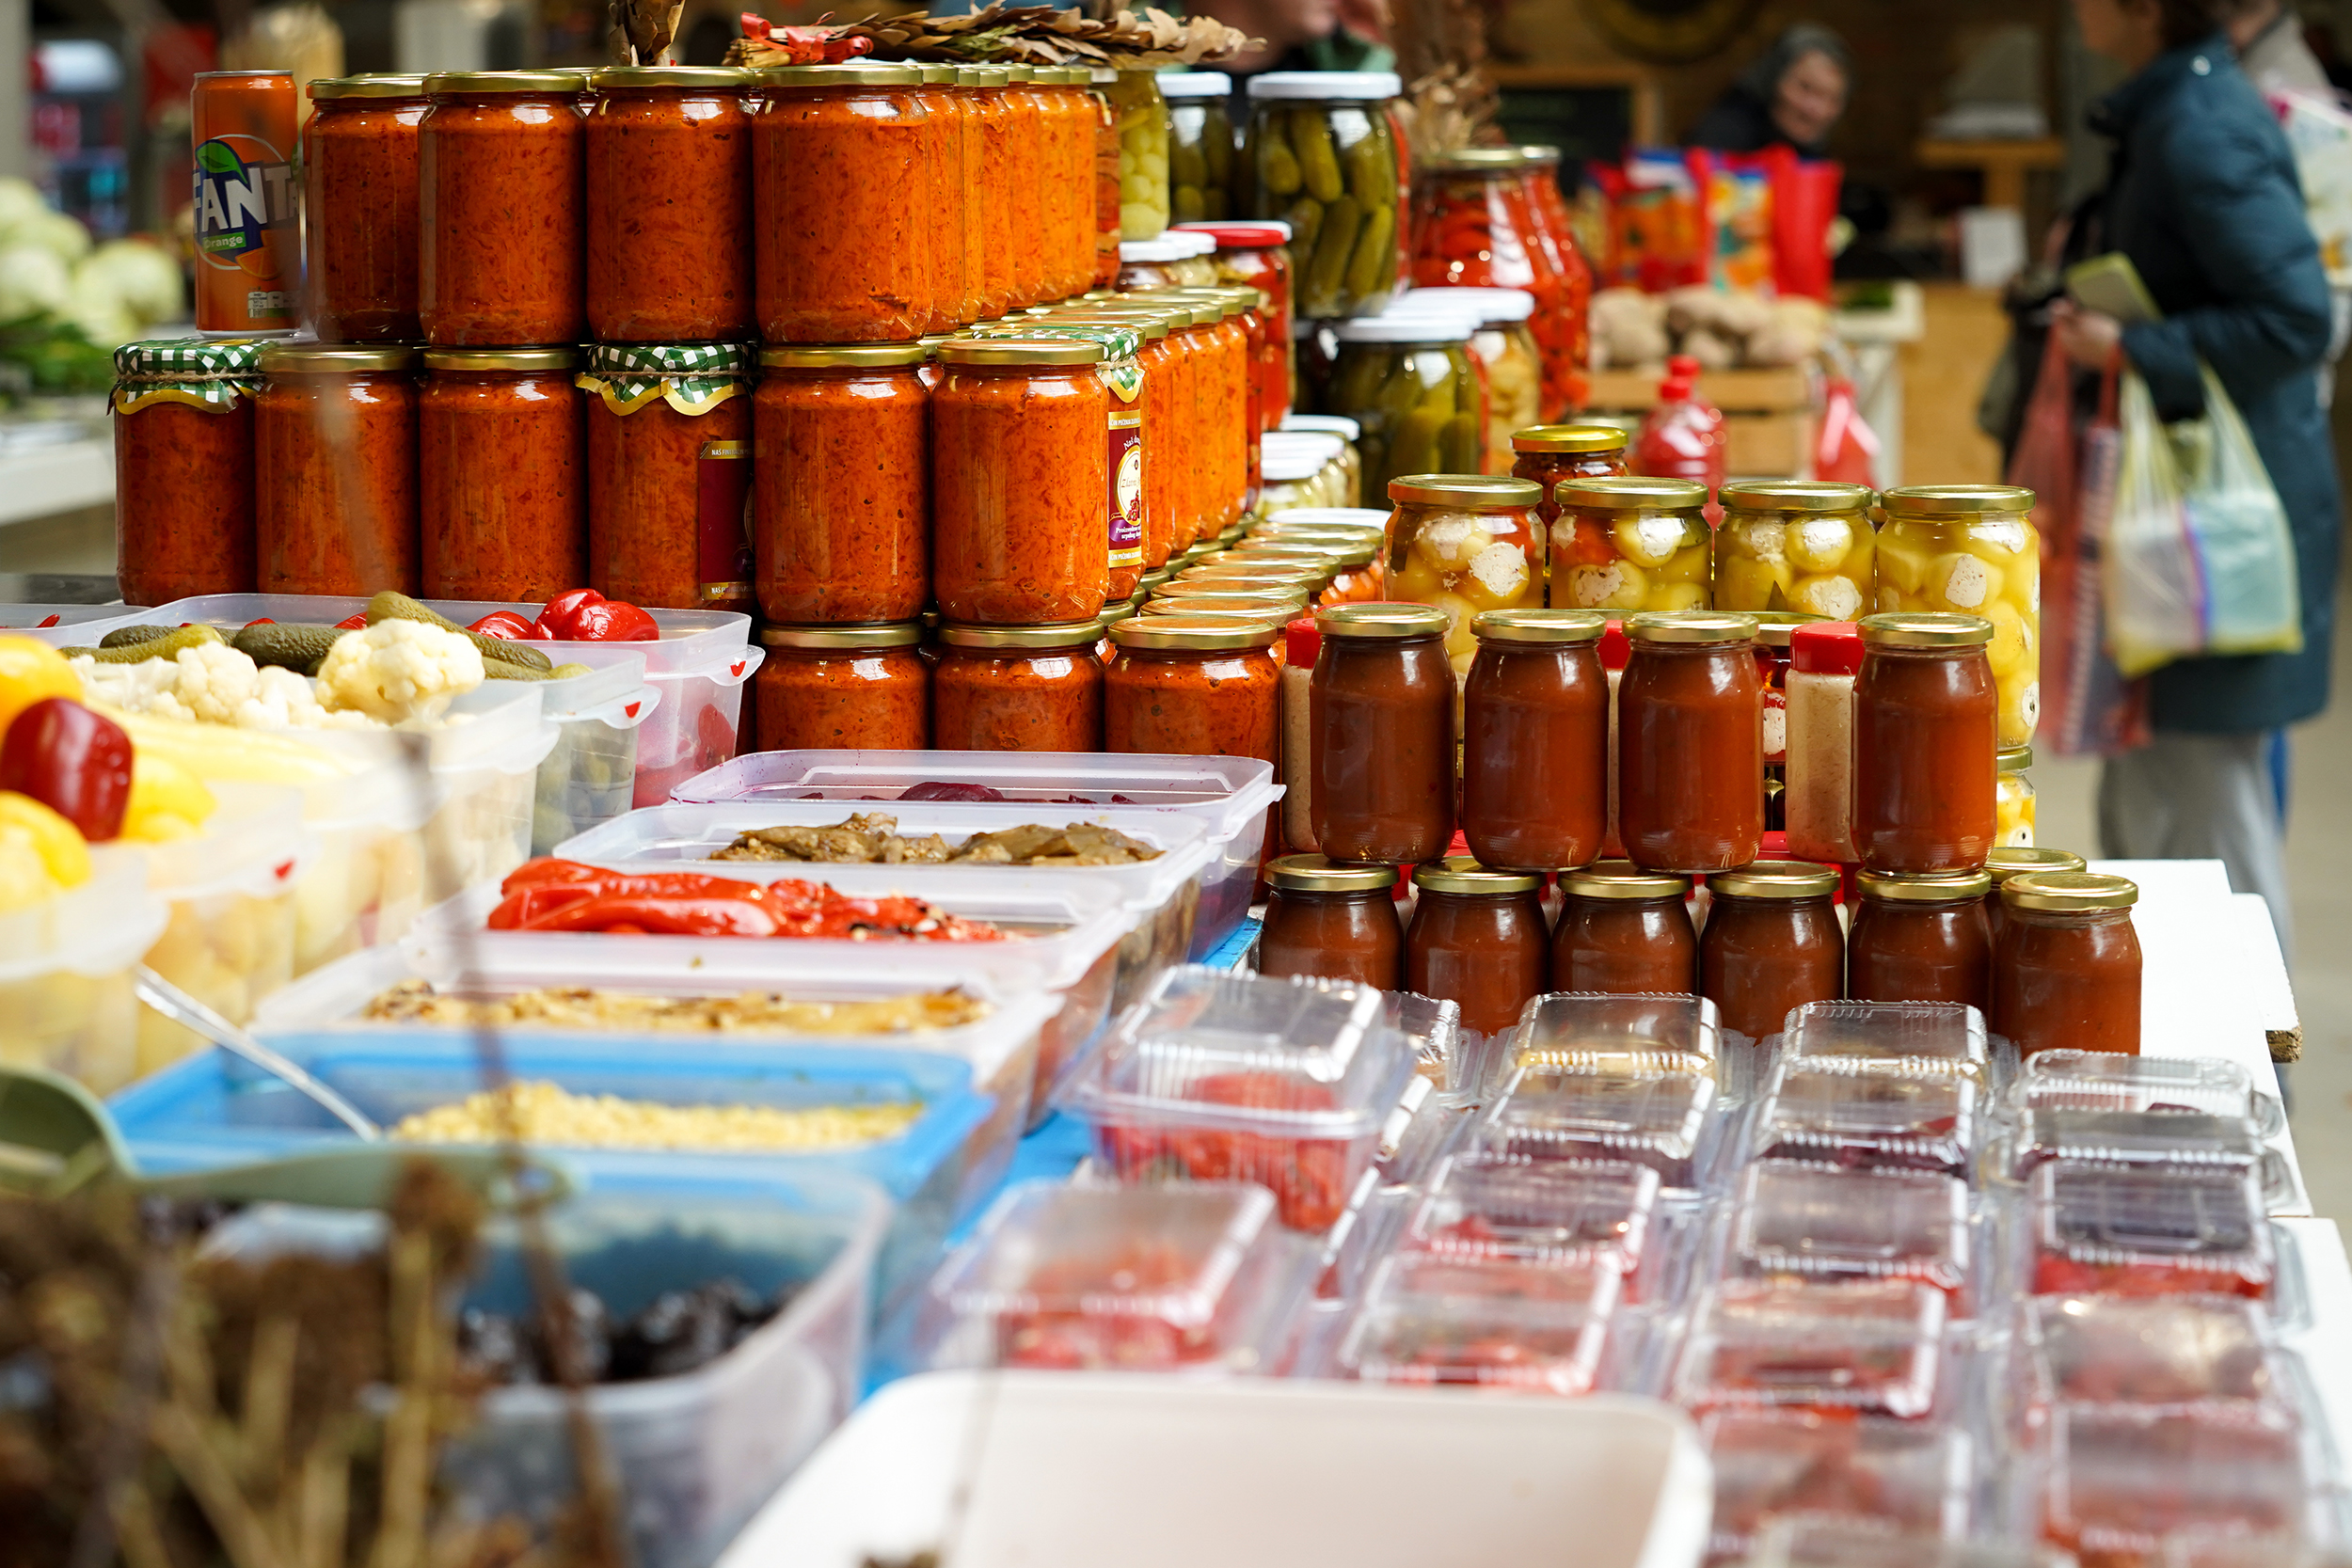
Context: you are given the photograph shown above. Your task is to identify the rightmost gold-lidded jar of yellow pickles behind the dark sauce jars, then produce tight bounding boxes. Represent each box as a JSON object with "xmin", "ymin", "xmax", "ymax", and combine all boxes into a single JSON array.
[{"xmin": 1872, "ymin": 484, "xmax": 2042, "ymax": 745}]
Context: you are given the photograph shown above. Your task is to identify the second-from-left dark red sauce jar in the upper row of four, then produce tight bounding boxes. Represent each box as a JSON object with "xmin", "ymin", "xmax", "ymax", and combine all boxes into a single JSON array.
[{"xmin": 1463, "ymin": 609, "xmax": 1609, "ymax": 872}]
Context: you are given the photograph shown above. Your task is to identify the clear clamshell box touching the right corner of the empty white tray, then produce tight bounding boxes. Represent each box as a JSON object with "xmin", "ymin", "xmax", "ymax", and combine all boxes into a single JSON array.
[{"xmin": 1698, "ymin": 1411, "xmax": 1976, "ymax": 1559}]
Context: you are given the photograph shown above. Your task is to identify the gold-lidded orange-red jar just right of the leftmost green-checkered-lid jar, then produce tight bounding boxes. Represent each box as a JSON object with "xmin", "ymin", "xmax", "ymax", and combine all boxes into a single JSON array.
[{"xmin": 254, "ymin": 345, "xmax": 423, "ymax": 594}]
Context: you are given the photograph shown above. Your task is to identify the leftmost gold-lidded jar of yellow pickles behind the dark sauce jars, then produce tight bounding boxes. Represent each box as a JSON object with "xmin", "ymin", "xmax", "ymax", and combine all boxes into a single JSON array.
[{"xmin": 1386, "ymin": 472, "xmax": 1543, "ymax": 677}]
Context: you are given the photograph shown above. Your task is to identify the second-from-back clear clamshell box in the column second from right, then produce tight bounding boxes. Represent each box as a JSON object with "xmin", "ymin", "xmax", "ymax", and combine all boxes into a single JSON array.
[{"xmin": 1755, "ymin": 1058, "xmax": 1979, "ymax": 1176}]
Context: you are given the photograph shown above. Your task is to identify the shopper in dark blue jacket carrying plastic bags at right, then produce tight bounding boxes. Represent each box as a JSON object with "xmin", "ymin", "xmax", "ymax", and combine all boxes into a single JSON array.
[{"xmin": 2051, "ymin": 0, "xmax": 2341, "ymax": 958}]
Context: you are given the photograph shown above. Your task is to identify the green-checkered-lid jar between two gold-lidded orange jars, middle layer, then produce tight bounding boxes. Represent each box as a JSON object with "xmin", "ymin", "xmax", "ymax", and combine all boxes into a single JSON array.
[{"xmin": 579, "ymin": 343, "xmax": 753, "ymax": 613}]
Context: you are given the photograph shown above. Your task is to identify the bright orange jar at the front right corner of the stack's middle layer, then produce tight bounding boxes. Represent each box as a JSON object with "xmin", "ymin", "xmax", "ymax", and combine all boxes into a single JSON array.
[{"xmin": 931, "ymin": 339, "xmax": 1110, "ymax": 626}]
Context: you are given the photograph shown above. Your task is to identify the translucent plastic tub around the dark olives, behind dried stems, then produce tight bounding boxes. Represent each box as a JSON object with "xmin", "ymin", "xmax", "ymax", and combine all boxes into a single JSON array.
[{"xmin": 205, "ymin": 1171, "xmax": 889, "ymax": 1568}]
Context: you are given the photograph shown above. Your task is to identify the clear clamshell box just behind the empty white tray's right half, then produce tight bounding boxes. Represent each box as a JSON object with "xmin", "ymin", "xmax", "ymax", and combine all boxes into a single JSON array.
[{"xmin": 1339, "ymin": 1253, "xmax": 1623, "ymax": 1394}]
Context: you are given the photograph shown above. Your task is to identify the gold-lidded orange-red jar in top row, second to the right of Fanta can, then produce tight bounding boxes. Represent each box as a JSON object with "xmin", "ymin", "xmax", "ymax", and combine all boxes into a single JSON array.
[{"xmin": 417, "ymin": 71, "xmax": 588, "ymax": 348}]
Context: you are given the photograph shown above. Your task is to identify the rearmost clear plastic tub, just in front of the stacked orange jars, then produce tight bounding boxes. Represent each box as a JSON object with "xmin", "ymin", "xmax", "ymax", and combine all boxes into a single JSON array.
[{"xmin": 671, "ymin": 752, "xmax": 1282, "ymax": 959}]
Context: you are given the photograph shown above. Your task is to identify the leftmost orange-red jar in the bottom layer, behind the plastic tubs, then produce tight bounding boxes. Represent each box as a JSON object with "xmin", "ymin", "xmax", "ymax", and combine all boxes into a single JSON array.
[{"xmin": 751, "ymin": 621, "xmax": 931, "ymax": 752}]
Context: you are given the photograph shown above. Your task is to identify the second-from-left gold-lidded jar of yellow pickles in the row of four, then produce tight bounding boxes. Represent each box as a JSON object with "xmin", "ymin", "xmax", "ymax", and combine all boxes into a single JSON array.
[{"xmin": 1550, "ymin": 475, "xmax": 1710, "ymax": 613}]
